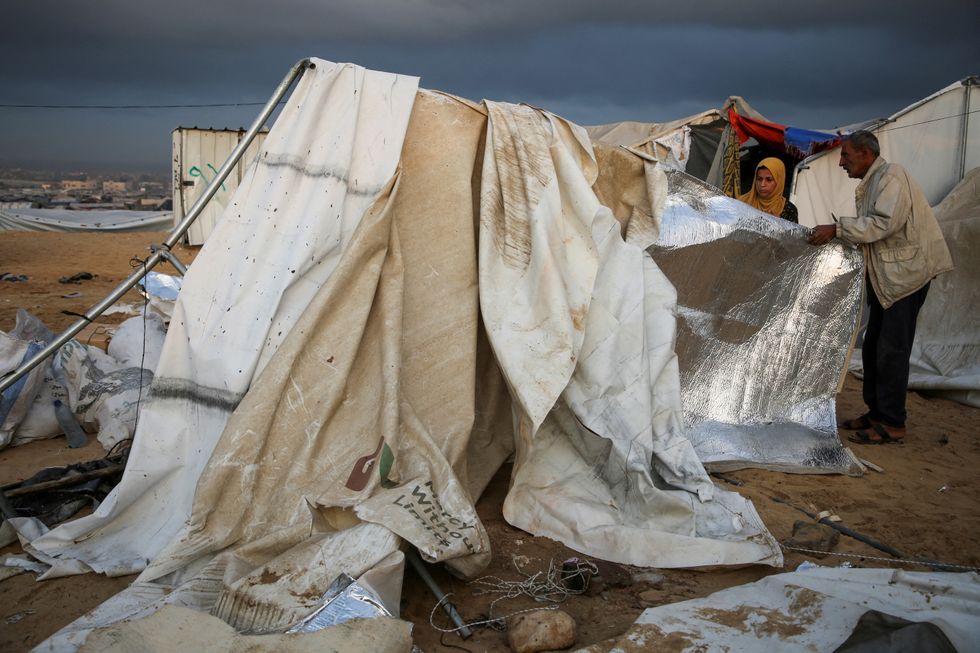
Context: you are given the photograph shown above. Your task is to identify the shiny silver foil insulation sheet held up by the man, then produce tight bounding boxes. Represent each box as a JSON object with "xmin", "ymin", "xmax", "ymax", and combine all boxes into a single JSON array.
[{"xmin": 648, "ymin": 171, "xmax": 863, "ymax": 474}]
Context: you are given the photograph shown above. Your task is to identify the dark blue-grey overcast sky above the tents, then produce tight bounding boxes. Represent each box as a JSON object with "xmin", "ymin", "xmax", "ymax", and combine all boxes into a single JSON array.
[{"xmin": 0, "ymin": 0, "xmax": 980, "ymax": 171}]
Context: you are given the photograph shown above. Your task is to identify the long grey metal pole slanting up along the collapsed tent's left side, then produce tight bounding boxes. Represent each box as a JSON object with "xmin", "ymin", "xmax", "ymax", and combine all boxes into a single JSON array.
[{"xmin": 0, "ymin": 59, "xmax": 314, "ymax": 392}]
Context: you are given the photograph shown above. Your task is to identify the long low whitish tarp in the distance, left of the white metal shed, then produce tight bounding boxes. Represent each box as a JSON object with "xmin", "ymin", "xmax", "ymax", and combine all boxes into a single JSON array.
[{"xmin": 0, "ymin": 209, "xmax": 173, "ymax": 232}]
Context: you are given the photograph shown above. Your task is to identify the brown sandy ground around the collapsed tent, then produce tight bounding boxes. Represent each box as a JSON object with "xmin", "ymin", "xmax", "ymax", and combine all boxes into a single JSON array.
[{"xmin": 0, "ymin": 232, "xmax": 980, "ymax": 653}]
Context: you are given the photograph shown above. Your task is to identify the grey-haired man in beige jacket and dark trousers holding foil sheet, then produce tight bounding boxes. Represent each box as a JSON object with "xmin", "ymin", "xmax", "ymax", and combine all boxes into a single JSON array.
[{"xmin": 809, "ymin": 131, "xmax": 953, "ymax": 444}]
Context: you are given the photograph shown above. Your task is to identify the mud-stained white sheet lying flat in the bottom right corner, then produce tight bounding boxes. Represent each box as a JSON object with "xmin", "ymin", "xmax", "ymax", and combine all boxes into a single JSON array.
[{"xmin": 588, "ymin": 567, "xmax": 980, "ymax": 653}]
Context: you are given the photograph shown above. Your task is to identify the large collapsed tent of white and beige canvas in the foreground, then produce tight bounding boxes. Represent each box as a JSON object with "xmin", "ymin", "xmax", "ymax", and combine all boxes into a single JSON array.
[{"xmin": 3, "ymin": 61, "xmax": 860, "ymax": 648}]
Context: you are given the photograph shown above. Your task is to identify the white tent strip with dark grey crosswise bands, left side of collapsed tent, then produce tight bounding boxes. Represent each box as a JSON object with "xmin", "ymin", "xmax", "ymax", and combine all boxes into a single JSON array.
[{"xmin": 28, "ymin": 60, "xmax": 418, "ymax": 575}]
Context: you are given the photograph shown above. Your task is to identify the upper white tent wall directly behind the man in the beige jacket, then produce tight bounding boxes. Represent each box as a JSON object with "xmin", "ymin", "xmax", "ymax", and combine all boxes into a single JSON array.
[{"xmin": 790, "ymin": 76, "xmax": 980, "ymax": 227}]
